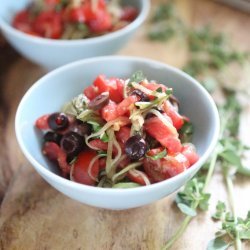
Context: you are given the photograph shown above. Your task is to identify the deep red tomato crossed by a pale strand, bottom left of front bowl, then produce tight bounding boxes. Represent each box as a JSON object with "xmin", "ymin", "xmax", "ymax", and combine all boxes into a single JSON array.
[{"xmin": 72, "ymin": 150, "xmax": 99, "ymax": 186}]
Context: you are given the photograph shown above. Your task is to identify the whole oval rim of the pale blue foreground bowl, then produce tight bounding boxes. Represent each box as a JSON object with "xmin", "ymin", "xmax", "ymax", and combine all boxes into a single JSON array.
[{"xmin": 15, "ymin": 56, "xmax": 220, "ymax": 195}]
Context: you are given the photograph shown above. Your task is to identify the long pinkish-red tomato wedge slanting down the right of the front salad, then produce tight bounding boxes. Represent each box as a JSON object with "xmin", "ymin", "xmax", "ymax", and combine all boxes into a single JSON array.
[{"xmin": 144, "ymin": 117, "xmax": 182, "ymax": 153}]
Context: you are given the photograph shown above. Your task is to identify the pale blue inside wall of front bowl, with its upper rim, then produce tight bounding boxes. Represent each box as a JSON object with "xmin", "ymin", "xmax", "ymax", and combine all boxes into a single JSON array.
[{"xmin": 16, "ymin": 57, "xmax": 218, "ymax": 178}]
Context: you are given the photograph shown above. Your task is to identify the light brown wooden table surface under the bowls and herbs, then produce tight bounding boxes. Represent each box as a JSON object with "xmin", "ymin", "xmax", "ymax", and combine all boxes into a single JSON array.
[{"xmin": 0, "ymin": 0, "xmax": 250, "ymax": 250}]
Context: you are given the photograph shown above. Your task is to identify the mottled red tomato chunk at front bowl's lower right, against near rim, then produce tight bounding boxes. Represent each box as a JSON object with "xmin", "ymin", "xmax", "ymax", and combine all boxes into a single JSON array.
[{"xmin": 143, "ymin": 153, "xmax": 189, "ymax": 182}]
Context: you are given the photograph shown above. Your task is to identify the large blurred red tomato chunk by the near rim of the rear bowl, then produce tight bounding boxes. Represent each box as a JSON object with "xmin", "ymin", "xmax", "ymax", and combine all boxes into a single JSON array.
[{"xmin": 33, "ymin": 11, "xmax": 63, "ymax": 39}]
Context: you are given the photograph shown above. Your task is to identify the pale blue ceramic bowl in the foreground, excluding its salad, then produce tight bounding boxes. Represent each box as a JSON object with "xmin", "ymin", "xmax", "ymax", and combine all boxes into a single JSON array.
[{"xmin": 15, "ymin": 56, "xmax": 219, "ymax": 209}]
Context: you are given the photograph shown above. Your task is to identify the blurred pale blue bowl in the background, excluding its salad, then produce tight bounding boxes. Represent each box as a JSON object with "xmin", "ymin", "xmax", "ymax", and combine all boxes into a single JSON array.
[{"xmin": 0, "ymin": 0, "xmax": 150, "ymax": 70}]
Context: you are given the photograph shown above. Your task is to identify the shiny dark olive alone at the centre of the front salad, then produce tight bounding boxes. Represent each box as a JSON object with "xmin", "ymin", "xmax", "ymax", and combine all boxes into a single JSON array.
[{"xmin": 125, "ymin": 135, "xmax": 147, "ymax": 160}]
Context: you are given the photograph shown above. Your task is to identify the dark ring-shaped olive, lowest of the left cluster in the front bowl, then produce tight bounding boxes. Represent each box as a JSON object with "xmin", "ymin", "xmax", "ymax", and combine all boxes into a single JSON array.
[{"xmin": 61, "ymin": 132, "xmax": 85, "ymax": 157}]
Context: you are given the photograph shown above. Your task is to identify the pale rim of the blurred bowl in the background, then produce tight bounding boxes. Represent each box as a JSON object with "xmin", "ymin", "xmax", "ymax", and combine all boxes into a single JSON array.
[{"xmin": 0, "ymin": 0, "xmax": 150, "ymax": 47}]
